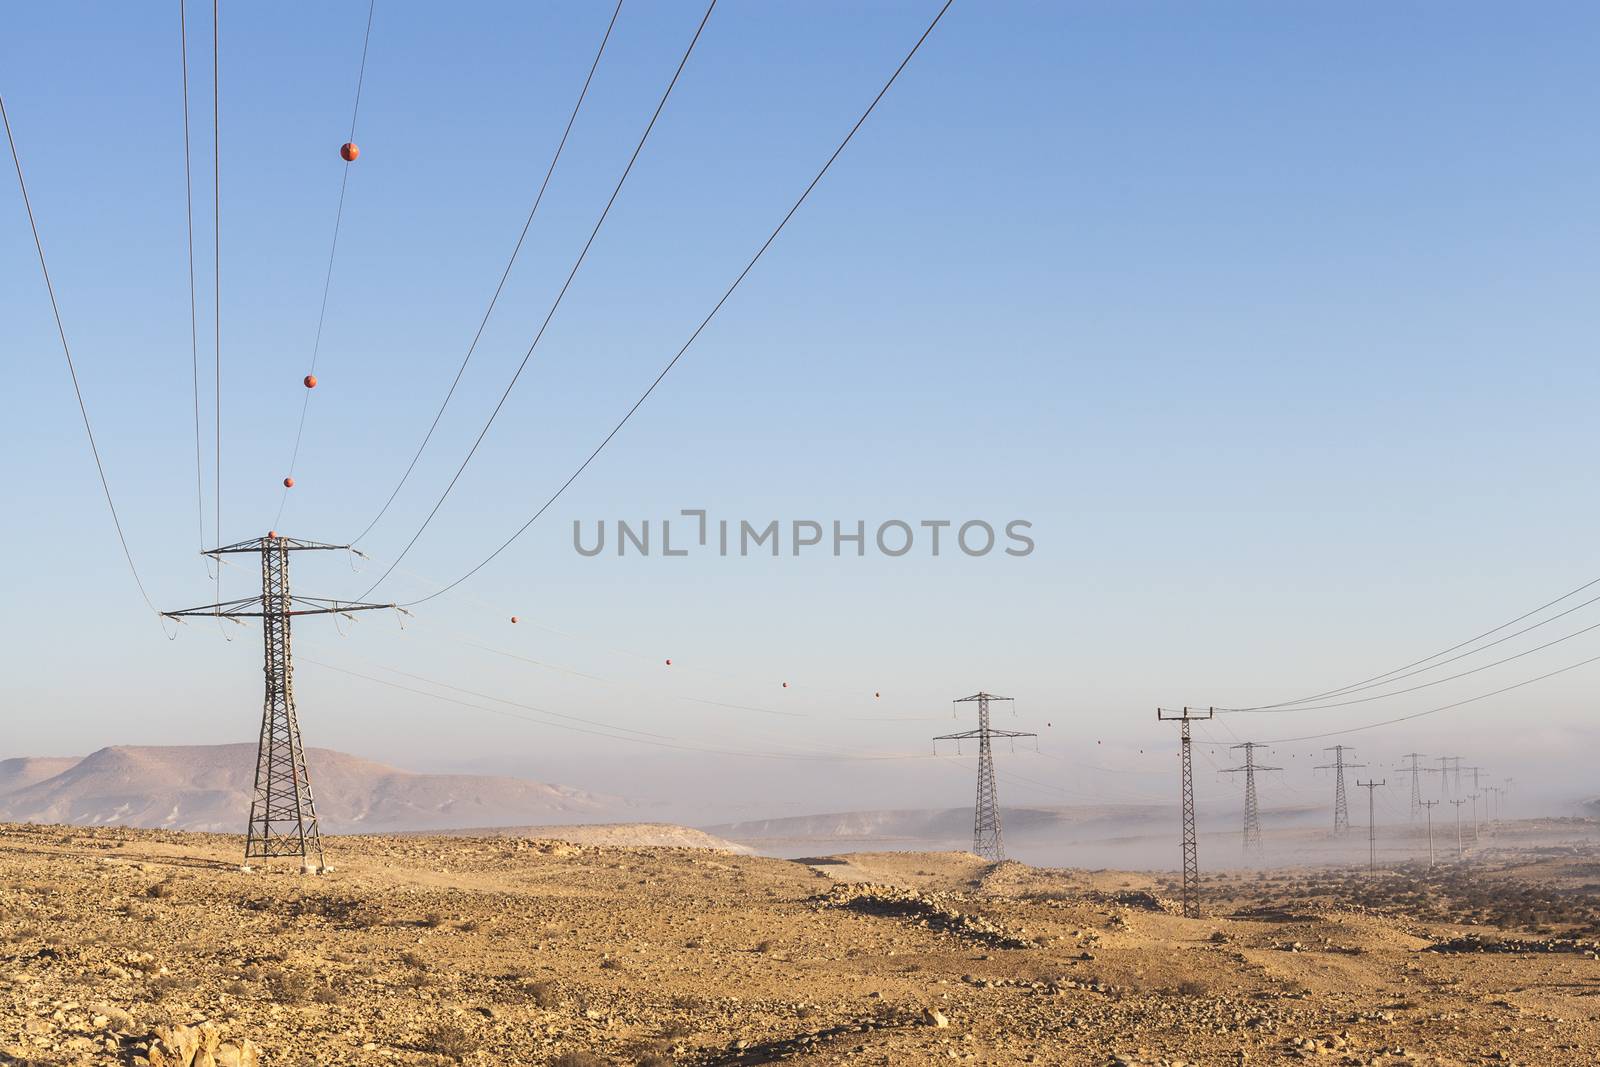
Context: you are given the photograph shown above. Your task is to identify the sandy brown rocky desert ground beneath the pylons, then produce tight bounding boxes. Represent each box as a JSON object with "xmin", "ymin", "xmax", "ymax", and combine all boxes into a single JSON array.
[{"xmin": 0, "ymin": 819, "xmax": 1600, "ymax": 1067}]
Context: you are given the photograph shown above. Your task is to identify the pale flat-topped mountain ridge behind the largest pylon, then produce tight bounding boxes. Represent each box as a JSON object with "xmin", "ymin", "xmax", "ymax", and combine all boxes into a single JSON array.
[{"xmin": 0, "ymin": 742, "xmax": 614, "ymax": 833}]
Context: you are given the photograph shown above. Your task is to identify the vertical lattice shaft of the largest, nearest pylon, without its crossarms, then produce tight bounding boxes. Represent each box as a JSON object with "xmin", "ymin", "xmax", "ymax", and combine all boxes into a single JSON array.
[{"xmin": 245, "ymin": 539, "xmax": 325, "ymax": 870}]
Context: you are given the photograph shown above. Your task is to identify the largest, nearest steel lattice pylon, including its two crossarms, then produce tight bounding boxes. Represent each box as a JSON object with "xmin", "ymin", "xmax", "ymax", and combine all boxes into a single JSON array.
[{"xmin": 162, "ymin": 533, "xmax": 395, "ymax": 873}]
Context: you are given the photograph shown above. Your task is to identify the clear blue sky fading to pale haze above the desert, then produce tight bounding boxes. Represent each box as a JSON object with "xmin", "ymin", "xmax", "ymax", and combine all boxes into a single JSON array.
[{"xmin": 0, "ymin": 0, "xmax": 1600, "ymax": 814}]
